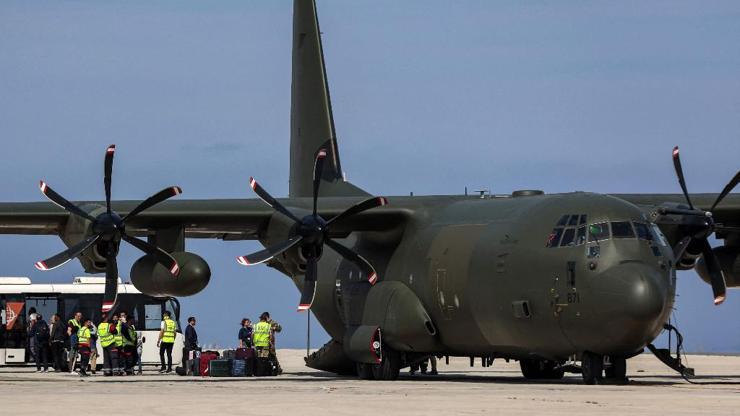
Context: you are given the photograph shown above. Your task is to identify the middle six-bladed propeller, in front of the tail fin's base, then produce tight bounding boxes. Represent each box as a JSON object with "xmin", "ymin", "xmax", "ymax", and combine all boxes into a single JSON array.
[{"xmin": 236, "ymin": 148, "xmax": 388, "ymax": 312}]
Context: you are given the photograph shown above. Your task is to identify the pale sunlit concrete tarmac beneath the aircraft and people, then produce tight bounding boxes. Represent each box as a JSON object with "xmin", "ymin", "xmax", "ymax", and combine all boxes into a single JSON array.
[{"xmin": 0, "ymin": 350, "xmax": 740, "ymax": 416}]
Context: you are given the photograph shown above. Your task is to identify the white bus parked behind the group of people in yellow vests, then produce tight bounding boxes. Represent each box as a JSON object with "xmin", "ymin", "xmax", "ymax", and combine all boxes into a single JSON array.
[{"xmin": 0, "ymin": 276, "xmax": 184, "ymax": 366}]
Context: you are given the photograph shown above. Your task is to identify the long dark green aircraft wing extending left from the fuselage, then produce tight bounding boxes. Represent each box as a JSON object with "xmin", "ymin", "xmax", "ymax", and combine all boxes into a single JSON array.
[{"xmin": 0, "ymin": 197, "xmax": 410, "ymax": 240}]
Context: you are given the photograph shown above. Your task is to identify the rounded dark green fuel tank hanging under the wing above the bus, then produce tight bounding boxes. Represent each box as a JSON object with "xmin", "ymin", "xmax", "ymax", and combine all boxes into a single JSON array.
[{"xmin": 130, "ymin": 252, "xmax": 211, "ymax": 296}]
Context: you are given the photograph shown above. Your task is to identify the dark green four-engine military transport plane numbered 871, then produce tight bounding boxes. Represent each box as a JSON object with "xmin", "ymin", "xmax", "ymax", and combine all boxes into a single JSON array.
[{"xmin": 0, "ymin": 0, "xmax": 740, "ymax": 383}]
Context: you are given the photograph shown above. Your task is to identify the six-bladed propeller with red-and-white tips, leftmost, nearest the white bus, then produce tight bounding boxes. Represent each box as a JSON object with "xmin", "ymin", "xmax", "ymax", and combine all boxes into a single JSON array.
[{"xmin": 35, "ymin": 145, "xmax": 182, "ymax": 319}]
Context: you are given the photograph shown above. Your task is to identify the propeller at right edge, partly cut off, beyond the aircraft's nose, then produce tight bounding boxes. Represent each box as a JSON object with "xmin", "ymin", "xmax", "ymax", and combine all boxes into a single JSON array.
[{"xmin": 658, "ymin": 146, "xmax": 740, "ymax": 305}]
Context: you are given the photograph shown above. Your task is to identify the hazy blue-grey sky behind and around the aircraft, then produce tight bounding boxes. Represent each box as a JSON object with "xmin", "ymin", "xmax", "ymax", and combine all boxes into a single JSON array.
[{"xmin": 0, "ymin": 0, "xmax": 740, "ymax": 352}]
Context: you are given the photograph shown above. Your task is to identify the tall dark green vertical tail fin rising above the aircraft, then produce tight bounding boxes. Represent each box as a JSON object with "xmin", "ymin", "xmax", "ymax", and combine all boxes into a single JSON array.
[{"xmin": 289, "ymin": 0, "xmax": 368, "ymax": 197}]
